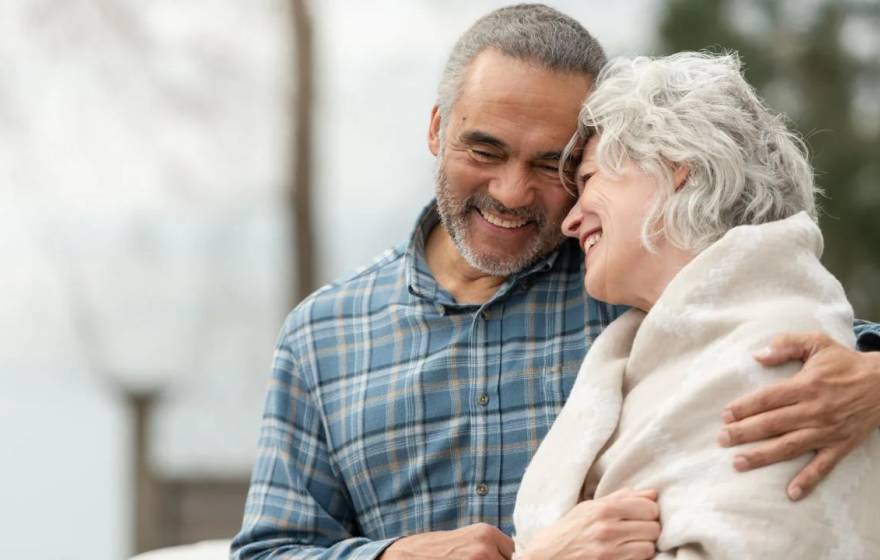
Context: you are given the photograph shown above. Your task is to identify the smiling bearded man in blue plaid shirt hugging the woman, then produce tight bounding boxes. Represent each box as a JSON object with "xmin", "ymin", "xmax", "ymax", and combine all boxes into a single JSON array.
[{"xmin": 232, "ymin": 5, "xmax": 880, "ymax": 558}]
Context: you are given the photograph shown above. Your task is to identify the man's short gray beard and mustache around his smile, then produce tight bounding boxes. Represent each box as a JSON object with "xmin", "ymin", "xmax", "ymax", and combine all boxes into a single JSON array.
[{"xmin": 434, "ymin": 153, "xmax": 565, "ymax": 276}]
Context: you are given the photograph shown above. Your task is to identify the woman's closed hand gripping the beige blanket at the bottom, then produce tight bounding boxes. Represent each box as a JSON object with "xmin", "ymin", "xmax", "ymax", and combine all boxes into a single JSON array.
[{"xmin": 517, "ymin": 489, "xmax": 660, "ymax": 560}]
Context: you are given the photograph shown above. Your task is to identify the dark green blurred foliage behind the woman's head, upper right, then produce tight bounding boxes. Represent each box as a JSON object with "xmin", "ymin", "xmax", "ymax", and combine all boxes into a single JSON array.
[{"xmin": 658, "ymin": 0, "xmax": 880, "ymax": 321}]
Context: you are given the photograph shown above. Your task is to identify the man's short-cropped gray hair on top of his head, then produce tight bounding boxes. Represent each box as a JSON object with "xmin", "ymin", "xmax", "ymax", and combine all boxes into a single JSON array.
[{"xmin": 437, "ymin": 4, "xmax": 606, "ymax": 127}]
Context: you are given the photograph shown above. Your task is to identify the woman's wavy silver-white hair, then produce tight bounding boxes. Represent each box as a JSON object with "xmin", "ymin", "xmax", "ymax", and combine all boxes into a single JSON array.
[{"xmin": 563, "ymin": 52, "xmax": 818, "ymax": 251}]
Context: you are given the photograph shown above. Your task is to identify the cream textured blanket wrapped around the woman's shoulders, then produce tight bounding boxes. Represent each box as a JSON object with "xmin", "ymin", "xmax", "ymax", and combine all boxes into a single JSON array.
[{"xmin": 514, "ymin": 214, "xmax": 880, "ymax": 560}]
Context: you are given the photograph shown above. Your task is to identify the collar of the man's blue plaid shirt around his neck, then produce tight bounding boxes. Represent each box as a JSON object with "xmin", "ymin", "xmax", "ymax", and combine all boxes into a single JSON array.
[{"xmin": 405, "ymin": 200, "xmax": 559, "ymax": 308}]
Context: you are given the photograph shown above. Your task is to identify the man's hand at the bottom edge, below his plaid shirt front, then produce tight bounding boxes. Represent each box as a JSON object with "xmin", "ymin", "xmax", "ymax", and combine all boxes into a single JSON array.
[{"xmin": 379, "ymin": 523, "xmax": 513, "ymax": 560}]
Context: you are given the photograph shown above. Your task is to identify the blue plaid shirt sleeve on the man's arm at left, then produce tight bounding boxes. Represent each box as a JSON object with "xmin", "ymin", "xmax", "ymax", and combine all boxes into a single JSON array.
[{"xmin": 230, "ymin": 326, "xmax": 395, "ymax": 559}]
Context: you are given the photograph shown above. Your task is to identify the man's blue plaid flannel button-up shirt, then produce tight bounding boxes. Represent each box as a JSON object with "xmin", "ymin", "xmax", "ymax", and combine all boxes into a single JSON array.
[{"xmin": 232, "ymin": 200, "xmax": 880, "ymax": 559}]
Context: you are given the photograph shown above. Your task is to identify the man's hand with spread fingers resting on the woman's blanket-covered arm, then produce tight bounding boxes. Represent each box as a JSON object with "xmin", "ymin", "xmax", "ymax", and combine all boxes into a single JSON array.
[{"xmin": 718, "ymin": 333, "xmax": 880, "ymax": 500}]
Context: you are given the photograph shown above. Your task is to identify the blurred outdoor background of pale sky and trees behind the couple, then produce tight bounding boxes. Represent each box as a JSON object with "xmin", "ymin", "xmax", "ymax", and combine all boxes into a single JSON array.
[{"xmin": 0, "ymin": 0, "xmax": 880, "ymax": 560}]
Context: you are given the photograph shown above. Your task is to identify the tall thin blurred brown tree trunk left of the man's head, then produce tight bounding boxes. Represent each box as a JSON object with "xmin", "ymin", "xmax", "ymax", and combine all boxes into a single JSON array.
[{"xmin": 289, "ymin": 0, "xmax": 316, "ymax": 303}]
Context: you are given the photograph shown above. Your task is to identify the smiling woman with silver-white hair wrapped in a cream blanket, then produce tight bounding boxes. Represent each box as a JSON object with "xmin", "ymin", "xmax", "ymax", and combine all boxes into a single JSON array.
[{"xmin": 514, "ymin": 53, "xmax": 880, "ymax": 559}]
